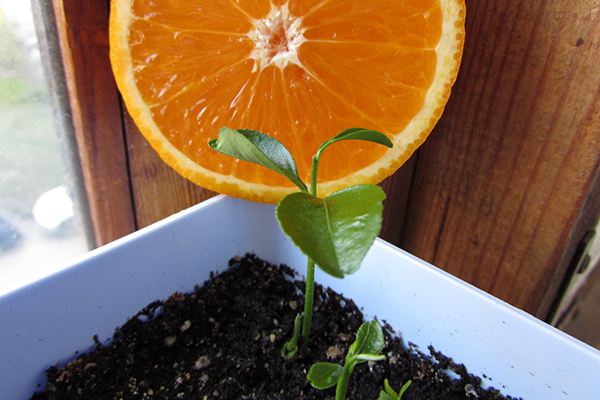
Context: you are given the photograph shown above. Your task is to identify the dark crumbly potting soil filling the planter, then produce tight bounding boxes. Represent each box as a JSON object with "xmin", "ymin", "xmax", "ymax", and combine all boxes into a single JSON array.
[{"xmin": 33, "ymin": 255, "xmax": 510, "ymax": 400}]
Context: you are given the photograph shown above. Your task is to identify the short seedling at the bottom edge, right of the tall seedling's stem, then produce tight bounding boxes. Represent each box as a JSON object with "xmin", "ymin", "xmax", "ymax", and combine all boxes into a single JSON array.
[{"xmin": 307, "ymin": 320, "xmax": 385, "ymax": 400}]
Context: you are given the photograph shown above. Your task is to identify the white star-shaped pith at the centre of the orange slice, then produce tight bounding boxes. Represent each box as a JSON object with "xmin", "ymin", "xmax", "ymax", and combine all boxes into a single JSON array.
[{"xmin": 248, "ymin": 3, "xmax": 306, "ymax": 72}]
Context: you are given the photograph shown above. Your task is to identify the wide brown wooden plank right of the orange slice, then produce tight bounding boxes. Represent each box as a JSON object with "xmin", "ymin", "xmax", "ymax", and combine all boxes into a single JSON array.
[{"xmin": 402, "ymin": 0, "xmax": 600, "ymax": 316}]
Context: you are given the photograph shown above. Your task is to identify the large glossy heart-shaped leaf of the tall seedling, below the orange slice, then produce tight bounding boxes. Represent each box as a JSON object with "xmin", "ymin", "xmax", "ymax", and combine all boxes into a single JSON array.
[{"xmin": 276, "ymin": 185, "xmax": 385, "ymax": 278}]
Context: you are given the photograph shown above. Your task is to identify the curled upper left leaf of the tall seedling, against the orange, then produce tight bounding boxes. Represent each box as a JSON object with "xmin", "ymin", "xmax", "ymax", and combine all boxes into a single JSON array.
[{"xmin": 208, "ymin": 127, "xmax": 308, "ymax": 192}]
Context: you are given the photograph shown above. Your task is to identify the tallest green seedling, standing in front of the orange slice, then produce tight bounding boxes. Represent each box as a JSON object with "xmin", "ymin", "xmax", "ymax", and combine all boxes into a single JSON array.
[{"xmin": 209, "ymin": 127, "xmax": 393, "ymax": 357}]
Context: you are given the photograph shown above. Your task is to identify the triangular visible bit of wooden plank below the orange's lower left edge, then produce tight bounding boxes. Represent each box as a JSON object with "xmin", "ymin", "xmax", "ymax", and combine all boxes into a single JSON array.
[{"xmin": 123, "ymin": 112, "xmax": 216, "ymax": 229}]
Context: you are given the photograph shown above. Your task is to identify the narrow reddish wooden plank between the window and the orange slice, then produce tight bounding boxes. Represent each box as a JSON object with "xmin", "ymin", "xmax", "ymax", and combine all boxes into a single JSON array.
[{"xmin": 53, "ymin": 0, "xmax": 135, "ymax": 246}]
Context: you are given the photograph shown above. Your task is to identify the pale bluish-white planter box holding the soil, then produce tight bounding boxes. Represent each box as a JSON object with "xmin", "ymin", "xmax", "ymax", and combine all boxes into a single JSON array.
[{"xmin": 0, "ymin": 196, "xmax": 600, "ymax": 400}]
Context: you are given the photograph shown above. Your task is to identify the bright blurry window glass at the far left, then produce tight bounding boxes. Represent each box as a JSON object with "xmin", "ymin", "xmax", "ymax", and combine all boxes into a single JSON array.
[{"xmin": 0, "ymin": 0, "xmax": 87, "ymax": 294}]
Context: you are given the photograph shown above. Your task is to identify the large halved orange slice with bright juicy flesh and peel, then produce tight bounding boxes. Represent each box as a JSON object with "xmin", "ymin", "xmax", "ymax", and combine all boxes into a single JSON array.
[{"xmin": 110, "ymin": 0, "xmax": 465, "ymax": 203}]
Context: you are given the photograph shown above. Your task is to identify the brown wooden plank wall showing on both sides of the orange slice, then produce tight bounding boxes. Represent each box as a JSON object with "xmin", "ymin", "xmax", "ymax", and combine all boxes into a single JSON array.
[{"xmin": 51, "ymin": 0, "xmax": 600, "ymax": 318}]
